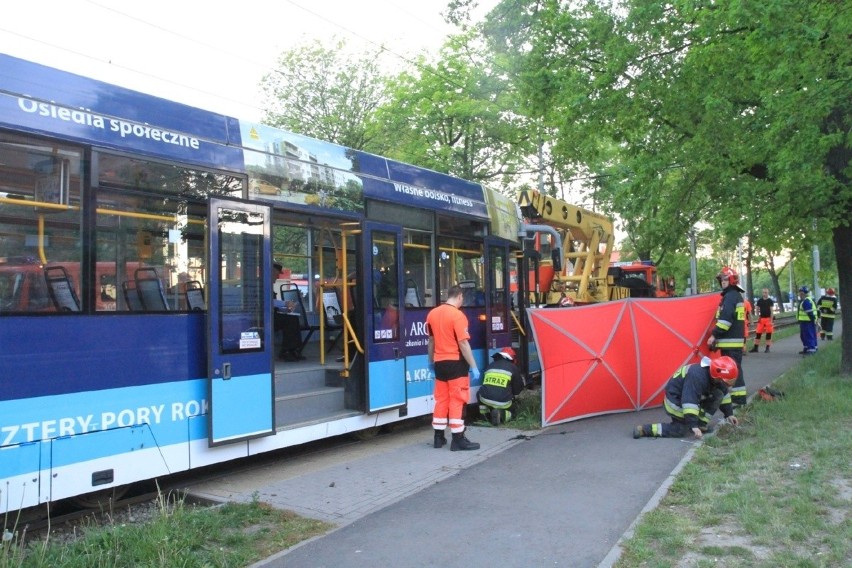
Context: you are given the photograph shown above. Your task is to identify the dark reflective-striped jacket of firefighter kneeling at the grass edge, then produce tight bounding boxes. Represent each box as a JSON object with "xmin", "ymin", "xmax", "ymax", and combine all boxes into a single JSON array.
[{"xmin": 666, "ymin": 363, "xmax": 734, "ymax": 428}]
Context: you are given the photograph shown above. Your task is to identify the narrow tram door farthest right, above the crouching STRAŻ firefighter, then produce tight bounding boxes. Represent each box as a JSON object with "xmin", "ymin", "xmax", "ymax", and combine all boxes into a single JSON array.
[{"xmin": 485, "ymin": 238, "xmax": 512, "ymax": 356}]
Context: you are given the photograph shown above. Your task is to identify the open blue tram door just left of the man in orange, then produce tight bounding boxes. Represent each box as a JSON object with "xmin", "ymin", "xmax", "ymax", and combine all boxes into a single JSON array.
[{"xmin": 361, "ymin": 222, "xmax": 406, "ymax": 412}]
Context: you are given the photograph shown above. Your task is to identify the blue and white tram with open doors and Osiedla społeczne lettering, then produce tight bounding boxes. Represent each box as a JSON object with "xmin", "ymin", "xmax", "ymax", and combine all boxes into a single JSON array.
[{"xmin": 0, "ymin": 55, "xmax": 520, "ymax": 511}]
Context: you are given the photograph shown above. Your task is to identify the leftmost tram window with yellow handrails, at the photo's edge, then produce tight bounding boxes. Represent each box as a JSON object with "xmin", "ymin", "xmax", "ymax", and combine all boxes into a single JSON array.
[{"xmin": 0, "ymin": 133, "xmax": 82, "ymax": 312}]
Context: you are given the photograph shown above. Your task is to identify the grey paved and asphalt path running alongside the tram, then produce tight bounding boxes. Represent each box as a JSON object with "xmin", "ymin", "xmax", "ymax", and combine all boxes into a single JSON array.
[{"xmin": 181, "ymin": 330, "xmax": 840, "ymax": 568}]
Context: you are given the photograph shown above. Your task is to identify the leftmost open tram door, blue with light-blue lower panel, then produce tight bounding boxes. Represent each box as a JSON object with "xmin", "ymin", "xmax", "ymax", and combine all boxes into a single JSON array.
[{"xmin": 207, "ymin": 198, "xmax": 275, "ymax": 446}]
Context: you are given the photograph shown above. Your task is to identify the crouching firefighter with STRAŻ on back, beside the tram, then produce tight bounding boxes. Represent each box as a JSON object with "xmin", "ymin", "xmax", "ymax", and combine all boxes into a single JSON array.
[{"xmin": 476, "ymin": 347, "xmax": 526, "ymax": 426}]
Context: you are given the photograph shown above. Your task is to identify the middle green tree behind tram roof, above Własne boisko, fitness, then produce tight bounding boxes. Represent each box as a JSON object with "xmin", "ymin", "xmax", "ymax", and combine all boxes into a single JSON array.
[{"xmin": 377, "ymin": 32, "xmax": 536, "ymax": 185}]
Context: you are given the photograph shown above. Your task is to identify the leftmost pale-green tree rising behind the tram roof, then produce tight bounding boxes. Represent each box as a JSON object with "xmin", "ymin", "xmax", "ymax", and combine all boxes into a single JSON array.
[{"xmin": 260, "ymin": 40, "xmax": 387, "ymax": 151}]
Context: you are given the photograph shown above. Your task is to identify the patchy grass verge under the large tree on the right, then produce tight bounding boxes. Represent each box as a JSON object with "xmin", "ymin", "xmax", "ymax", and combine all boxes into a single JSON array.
[{"xmin": 616, "ymin": 342, "xmax": 852, "ymax": 568}]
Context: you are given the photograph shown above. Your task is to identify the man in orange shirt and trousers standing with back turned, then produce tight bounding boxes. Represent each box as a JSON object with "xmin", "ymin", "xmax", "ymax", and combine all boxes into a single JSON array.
[{"xmin": 426, "ymin": 286, "xmax": 479, "ymax": 452}]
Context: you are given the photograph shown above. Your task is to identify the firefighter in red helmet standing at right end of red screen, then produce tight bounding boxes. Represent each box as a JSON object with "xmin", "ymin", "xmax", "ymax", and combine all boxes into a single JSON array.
[{"xmin": 707, "ymin": 266, "xmax": 748, "ymax": 407}]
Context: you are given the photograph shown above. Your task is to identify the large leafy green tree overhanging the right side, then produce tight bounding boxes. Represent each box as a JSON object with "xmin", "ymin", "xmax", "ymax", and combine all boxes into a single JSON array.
[{"xmin": 484, "ymin": 0, "xmax": 852, "ymax": 374}]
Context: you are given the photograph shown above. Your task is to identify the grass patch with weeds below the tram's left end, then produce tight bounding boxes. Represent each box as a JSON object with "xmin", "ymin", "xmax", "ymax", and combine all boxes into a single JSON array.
[{"xmin": 0, "ymin": 495, "xmax": 331, "ymax": 568}]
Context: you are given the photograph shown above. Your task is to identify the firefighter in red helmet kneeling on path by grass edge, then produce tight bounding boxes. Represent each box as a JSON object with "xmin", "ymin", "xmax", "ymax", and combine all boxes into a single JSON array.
[{"xmin": 633, "ymin": 357, "xmax": 739, "ymax": 440}]
